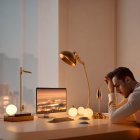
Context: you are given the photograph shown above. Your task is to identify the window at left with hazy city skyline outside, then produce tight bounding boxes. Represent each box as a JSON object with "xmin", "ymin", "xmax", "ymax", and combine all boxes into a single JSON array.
[{"xmin": 0, "ymin": 0, "xmax": 38, "ymax": 116}]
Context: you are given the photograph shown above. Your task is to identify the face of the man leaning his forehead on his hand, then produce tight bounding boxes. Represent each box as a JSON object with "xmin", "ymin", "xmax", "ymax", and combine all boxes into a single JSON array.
[{"xmin": 112, "ymin": 76, "xmax": 131, "ymax": 98}]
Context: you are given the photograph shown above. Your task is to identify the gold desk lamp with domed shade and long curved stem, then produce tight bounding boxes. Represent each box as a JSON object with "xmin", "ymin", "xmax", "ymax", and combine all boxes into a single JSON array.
[{"xmin": 59, "ymin": 51, "xmax": 91, "ymax": 108}]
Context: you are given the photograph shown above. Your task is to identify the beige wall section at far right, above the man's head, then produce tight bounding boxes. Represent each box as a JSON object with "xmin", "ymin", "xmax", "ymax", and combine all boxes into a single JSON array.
[{"xmin": 117, "ymin": 0, "xmax": 140, "ymax": 81}]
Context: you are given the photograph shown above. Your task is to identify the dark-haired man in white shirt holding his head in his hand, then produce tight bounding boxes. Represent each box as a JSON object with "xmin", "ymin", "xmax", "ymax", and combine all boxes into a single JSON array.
[{"xmin": 105, "ymin": 67, "xmax": 140, "ymax": 123}]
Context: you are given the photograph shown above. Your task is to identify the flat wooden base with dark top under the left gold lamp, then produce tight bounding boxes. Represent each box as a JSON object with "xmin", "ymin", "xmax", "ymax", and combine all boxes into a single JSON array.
[{"xmin": 4, "ymin": 113, "xmax": 34, "ymax": 122}]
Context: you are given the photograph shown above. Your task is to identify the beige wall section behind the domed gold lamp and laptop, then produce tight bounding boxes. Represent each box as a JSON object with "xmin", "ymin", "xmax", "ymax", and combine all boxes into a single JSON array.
[{"xmin": 59, "ymin": 0, "xmax": 116, "ymax": 112}]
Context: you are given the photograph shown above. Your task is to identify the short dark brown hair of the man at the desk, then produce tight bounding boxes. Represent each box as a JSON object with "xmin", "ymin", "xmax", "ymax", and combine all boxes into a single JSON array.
[{"xmin": 107, "ymin": 67, "xmax": 136, "ymax": 81}]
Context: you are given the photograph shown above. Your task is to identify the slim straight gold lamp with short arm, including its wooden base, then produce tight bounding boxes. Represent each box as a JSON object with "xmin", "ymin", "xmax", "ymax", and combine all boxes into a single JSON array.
[{"xmin": 4, "ymin": 67, "xmax": 34, "ymax": 122}]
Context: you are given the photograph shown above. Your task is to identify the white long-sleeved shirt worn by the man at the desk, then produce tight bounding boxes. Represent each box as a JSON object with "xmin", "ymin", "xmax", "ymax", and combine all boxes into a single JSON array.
[{"xmin": 108, "ymin": 85, "xmax": 140, "ymax": 123}]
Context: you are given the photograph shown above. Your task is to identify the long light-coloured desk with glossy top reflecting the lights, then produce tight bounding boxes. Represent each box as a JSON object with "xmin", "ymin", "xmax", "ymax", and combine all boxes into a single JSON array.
[{"xmin": 0, "ymin": 114, "xmax": 140, "ymax": 140}]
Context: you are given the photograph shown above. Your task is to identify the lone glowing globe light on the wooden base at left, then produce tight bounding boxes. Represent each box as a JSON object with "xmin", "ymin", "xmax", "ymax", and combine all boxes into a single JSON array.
[{"xmin": 6, "ymin": 104, "xmax": 17, "ymax": 116}]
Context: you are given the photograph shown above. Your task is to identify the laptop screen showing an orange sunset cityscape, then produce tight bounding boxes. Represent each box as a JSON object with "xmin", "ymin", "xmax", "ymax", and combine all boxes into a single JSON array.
[{"xmin": 36, "ymin": 88, "xmax": 67, "ymax": 114}]
